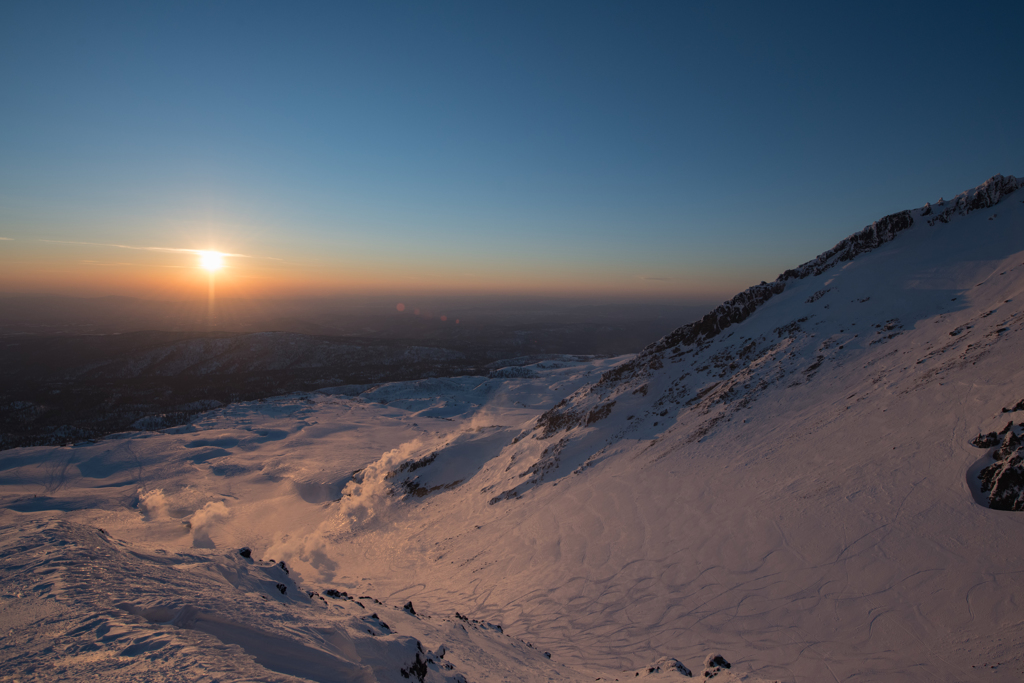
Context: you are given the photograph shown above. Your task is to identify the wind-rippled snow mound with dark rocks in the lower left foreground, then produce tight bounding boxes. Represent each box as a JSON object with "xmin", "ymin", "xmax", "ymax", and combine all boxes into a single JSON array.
[{"xmin": 0, "ymin": 521, "xmax": 571, "ymax": 683}]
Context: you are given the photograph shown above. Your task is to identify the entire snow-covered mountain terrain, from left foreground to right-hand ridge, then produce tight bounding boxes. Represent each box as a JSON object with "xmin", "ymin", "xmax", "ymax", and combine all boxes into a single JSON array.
[{"xmin": 0, "ymin": 176, "xmax": 1024, "ymax": 681}]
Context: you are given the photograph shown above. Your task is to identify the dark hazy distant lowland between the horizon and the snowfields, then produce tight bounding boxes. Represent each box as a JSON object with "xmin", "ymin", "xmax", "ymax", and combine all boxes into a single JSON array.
[{"xmin": 0, "ymin": 299, "xmax": 696, "ymax": 449}]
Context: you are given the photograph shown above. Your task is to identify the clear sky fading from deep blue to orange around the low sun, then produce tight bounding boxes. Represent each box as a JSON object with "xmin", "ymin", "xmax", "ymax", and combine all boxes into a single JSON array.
[{"xmin": 0, "ymin": 1, "xmax": 1024, "ymax": 301}]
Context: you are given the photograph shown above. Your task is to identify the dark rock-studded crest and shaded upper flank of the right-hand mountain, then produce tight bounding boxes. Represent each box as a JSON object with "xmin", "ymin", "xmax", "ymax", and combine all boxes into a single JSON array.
[{"xmin": 378, "ymin": 175, "xmax": 1024, "ymax": 516}]
